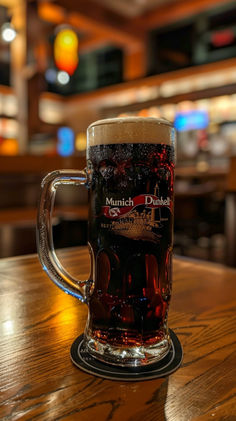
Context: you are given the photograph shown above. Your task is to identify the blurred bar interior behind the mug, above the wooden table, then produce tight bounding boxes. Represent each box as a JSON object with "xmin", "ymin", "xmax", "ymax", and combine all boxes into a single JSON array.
[{"xmin": 0, "ymin": 0, "xmax": 236, "ymax": 265}]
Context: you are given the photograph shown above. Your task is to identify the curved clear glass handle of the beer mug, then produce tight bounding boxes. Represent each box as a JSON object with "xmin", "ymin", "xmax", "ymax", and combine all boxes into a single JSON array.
[{"xmin": 36, "ymin": 170, "xmax": 91, "ymax": 302}]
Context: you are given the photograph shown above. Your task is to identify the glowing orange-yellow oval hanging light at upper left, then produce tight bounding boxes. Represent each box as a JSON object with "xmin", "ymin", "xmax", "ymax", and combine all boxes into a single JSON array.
[{"xmin": 54, "ymin": 29, "xmax": 79, "ymax": 76}]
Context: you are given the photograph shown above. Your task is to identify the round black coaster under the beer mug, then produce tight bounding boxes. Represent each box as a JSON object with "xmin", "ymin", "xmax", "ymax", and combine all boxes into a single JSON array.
[{"xmin": 70, "ymin": 329, "xmax": 183, "ymax": 381}]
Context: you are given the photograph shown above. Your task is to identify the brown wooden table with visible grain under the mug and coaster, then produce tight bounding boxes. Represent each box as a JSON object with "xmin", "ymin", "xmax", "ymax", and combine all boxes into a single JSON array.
[{"xmin": 0, "ymin": 248, "xmax": 236, "ymax": 421}]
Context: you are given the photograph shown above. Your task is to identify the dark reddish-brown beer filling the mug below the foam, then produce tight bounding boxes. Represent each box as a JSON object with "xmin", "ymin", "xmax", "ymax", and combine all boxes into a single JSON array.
[{"xmin": 87, "ymin": 123, "xmax": 174, "ymax": 360}]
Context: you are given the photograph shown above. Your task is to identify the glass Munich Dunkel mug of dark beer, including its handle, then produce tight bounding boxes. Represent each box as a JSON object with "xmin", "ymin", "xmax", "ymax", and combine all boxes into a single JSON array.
[{"xmin": 37, "ymin": 117, "xmax": 175, "ymax": 367}]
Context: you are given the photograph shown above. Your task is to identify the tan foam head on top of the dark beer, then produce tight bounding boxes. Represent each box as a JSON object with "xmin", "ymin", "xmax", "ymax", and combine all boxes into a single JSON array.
[{"xmin": 87, "ymin": 117, "xmax": 175, "ymax": 147}]
